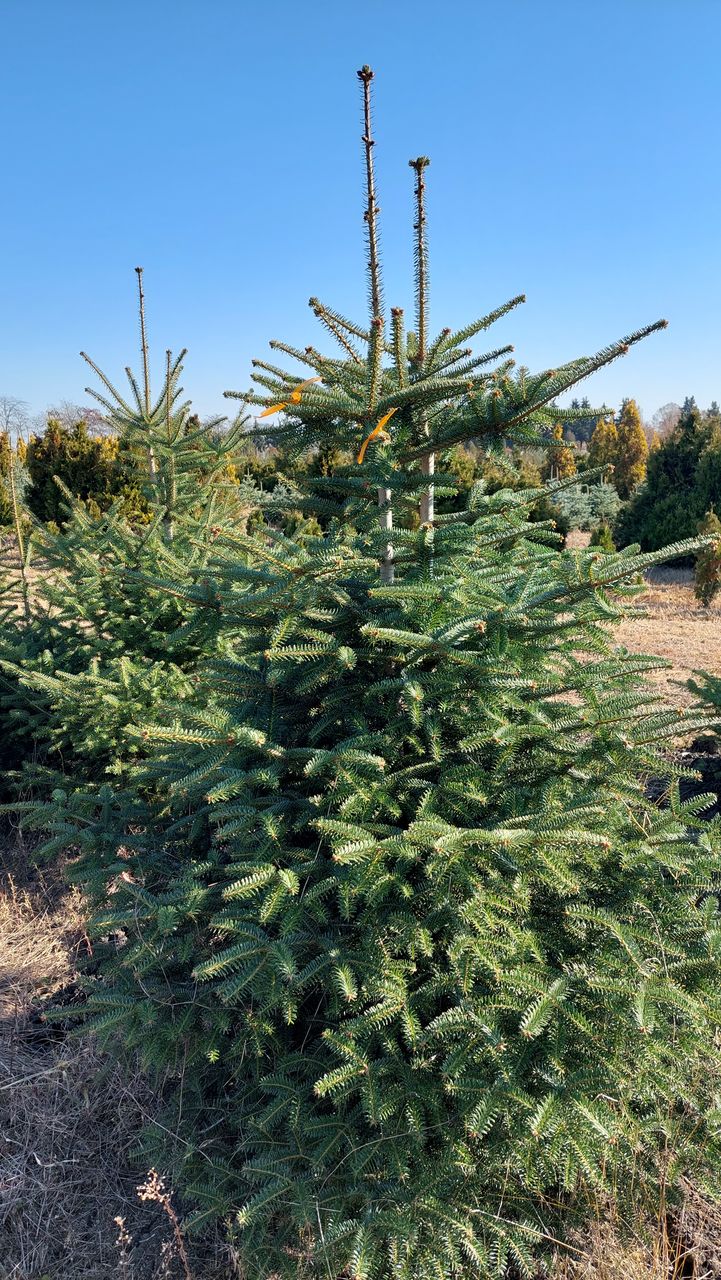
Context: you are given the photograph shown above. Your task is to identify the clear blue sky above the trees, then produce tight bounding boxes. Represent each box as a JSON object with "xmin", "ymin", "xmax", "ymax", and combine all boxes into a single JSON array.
[{"xmin": 0, "ymin": 0, "xmax": 721, "ymax": 430}]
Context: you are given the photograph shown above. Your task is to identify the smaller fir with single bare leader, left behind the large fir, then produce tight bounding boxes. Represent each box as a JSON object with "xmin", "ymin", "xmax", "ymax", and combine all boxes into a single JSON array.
[{"xmin": 0, "ymin": 269, "xmax": 250, "ymax": 794}]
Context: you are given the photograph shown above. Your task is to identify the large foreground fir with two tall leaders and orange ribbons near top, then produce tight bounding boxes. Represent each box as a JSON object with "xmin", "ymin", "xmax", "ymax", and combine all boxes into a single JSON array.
[{"xmin": 25, "ymin": 68, "xmax": 721, "ymax": 1280}]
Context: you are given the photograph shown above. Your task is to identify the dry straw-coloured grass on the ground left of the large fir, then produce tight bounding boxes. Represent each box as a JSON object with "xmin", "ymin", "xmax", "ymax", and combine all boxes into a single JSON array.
[{"xmin": 0, "ymin": 834, "xmax": 234, "ymax": 1280}]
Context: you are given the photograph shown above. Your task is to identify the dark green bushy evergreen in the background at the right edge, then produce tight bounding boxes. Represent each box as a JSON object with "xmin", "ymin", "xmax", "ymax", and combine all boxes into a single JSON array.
[{"xmin": 615, "ymin": 399, "xmax": 721, "ymax": 550}]
